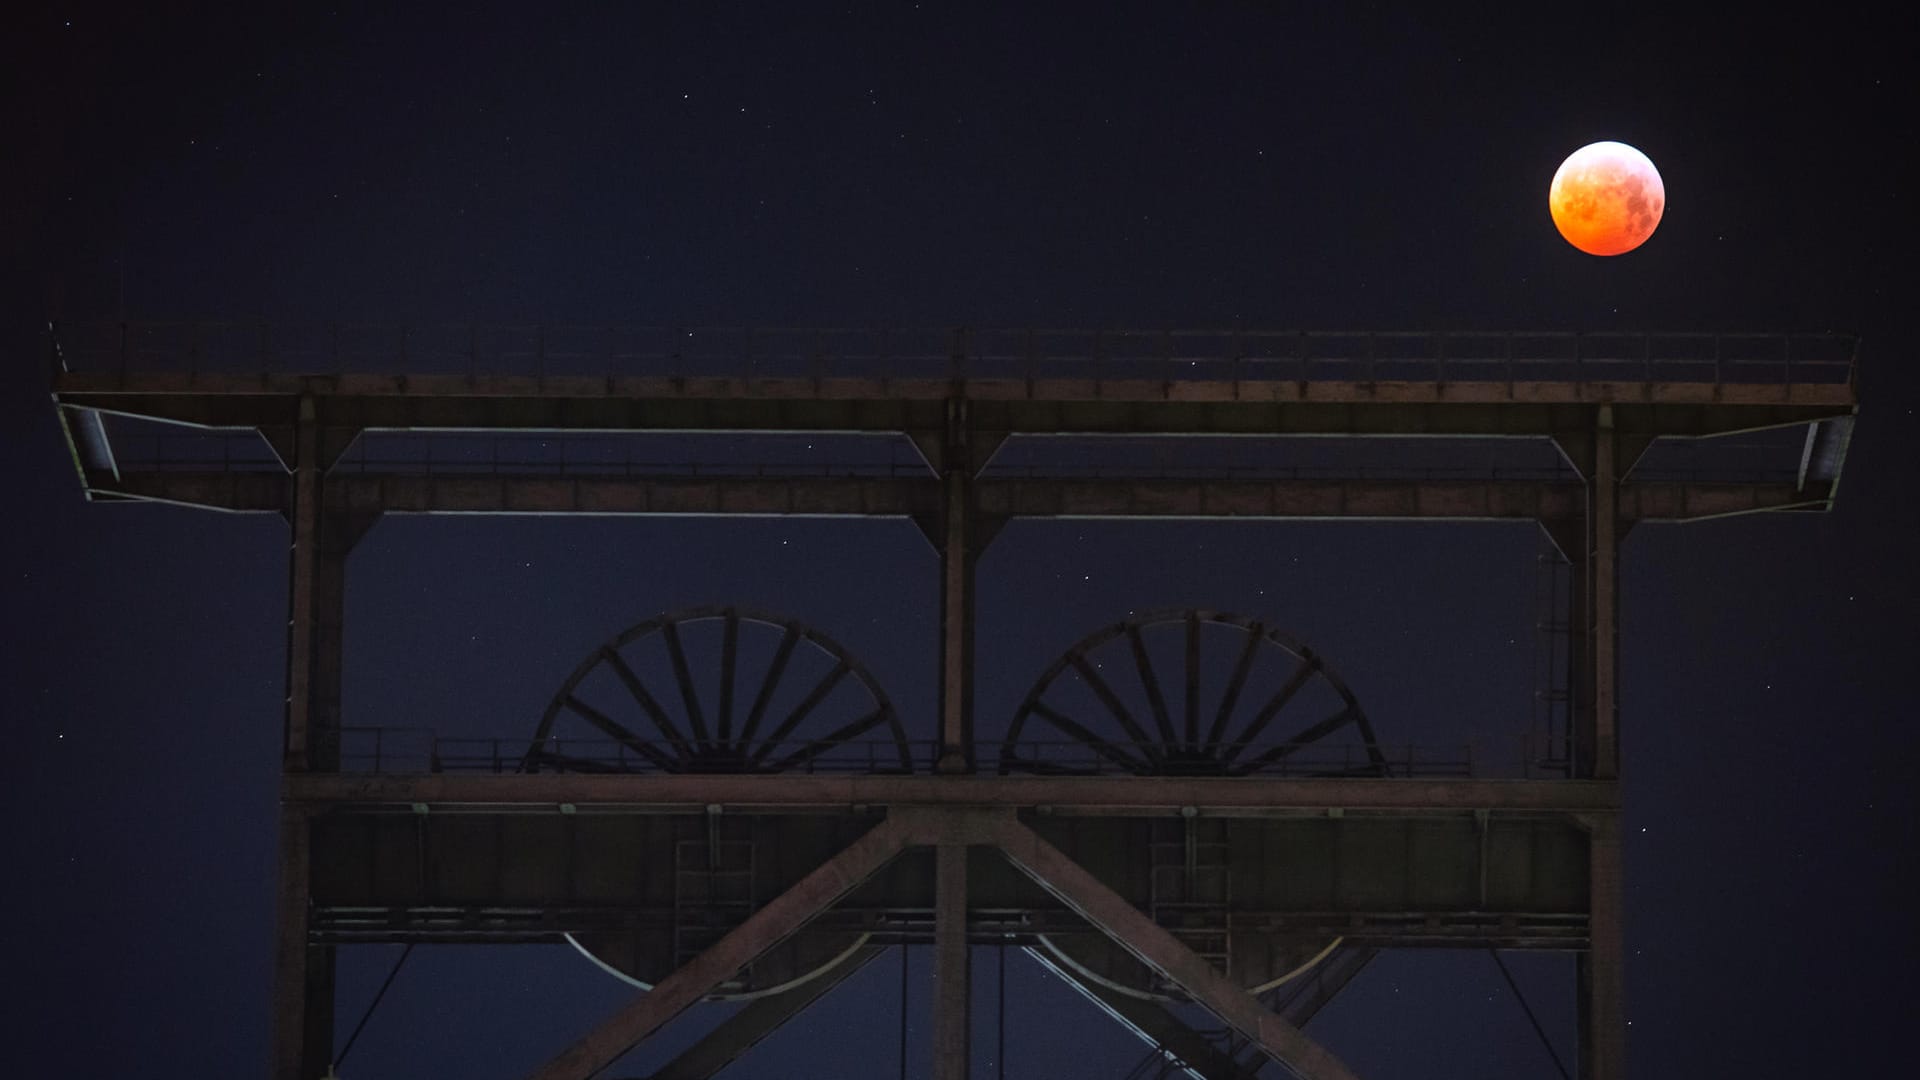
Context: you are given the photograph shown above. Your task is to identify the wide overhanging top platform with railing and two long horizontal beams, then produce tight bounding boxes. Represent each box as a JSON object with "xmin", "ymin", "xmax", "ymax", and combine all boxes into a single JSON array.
[{"xmin": 50, "ymin": 323, "xmax": 1859, "ymax": 519}]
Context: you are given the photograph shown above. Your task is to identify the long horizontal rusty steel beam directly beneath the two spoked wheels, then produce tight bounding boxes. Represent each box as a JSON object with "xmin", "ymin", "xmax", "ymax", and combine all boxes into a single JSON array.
[{"xmin": 280, "ymin": 773, "xmax": 1620, "ymax": 815}]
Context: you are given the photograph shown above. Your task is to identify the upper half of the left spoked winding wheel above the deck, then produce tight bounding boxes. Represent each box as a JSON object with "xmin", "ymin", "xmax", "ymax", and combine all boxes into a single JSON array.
[{"xmin": 522, "ymin": 607, "xmax": 914, "ymax": 773}]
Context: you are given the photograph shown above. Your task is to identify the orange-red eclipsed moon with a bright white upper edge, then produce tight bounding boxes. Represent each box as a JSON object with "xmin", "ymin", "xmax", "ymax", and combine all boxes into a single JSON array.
[{"xmin": 1548, "ymin": 142, "xmax": 1667, "ymax": 256}]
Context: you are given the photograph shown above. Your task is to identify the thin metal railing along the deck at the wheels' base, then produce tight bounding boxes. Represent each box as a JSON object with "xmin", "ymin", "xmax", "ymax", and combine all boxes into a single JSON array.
[{"xmin": 340, "ymin": 726, "xmax": 1571, "ymax": 778}]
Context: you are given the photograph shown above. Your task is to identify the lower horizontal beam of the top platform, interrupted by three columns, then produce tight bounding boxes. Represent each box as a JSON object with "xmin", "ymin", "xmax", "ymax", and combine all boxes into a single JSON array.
[{"xmin": 86, "ymin": 471, "xmax": 1834, "ymax": 522}]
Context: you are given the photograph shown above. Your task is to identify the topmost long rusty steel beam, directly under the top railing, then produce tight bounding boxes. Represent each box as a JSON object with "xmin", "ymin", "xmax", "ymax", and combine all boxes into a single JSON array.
[{"xmin": 54, "ymin": 373, "xmax": 1859, "ymax": 438}]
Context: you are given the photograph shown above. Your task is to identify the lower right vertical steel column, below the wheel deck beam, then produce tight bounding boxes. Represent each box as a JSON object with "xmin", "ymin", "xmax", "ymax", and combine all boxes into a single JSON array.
[{"xmin": 1574, "ymin": 813, "xmax": 1626, "ymax": 1080}]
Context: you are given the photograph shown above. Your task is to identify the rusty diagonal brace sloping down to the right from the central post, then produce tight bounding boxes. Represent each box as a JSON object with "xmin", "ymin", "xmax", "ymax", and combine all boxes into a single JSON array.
[{"xmin": 995, "ymin": 817, "xmax": 1357, "ymax": 1080}]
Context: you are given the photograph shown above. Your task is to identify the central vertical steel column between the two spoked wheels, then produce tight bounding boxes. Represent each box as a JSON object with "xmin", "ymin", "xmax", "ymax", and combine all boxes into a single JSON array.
[{"xmin": 935, "ymin": 388, "xmax": 979, "ymax": 773}]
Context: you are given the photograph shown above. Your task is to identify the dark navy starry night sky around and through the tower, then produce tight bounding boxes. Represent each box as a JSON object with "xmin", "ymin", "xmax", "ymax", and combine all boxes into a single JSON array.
[{"xmin": 0, "ymin": 2, "xmax": 1920, "ymax": 1080}]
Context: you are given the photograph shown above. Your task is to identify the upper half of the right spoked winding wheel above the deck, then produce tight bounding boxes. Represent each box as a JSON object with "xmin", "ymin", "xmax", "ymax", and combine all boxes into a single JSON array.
[{"xmin": 1000, "ymin": 609, "xmax": 1386, "ymax": 776}]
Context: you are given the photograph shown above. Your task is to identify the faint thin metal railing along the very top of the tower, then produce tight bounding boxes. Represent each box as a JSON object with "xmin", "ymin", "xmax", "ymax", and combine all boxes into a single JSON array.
[{"xmin": 50, "ymin": 321, "xmax": 1857, "ymax": 384}]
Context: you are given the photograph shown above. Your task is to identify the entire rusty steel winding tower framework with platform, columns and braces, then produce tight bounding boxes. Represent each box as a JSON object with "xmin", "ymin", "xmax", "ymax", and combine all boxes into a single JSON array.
[{"xmin": 52, "ymin": 323, "xmax": 1857, "ymax": 1080}]
